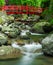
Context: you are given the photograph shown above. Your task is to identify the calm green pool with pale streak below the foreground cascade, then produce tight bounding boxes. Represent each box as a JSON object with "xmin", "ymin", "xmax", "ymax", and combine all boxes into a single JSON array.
[{"xmin": 0, "ymin": 53, "xmax": 53, "ymax": 65}]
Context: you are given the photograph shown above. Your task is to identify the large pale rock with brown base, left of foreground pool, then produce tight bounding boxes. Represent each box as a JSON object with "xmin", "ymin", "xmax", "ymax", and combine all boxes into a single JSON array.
[{"xmin": 0, "ymin": 46, "xmax": 21, "ymax": 60}]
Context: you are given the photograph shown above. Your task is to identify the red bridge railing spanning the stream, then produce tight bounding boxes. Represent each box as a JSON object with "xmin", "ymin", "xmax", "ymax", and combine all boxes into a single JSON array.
[{"xmin": 2, "ymin": 5, "xmax": 43, "ymax": 14}]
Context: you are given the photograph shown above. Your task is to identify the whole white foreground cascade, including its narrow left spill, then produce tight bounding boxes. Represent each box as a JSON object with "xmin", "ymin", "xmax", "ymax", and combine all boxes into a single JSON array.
[{"xmin": 12, "ymin": 42, "xmax": 42, "ymax": 54}]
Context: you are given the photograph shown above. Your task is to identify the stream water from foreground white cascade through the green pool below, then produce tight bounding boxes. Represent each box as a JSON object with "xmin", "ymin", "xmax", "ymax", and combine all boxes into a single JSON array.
[{"xmin": 0, "ymin": 31, "xmax": 53, "ymax": 65}]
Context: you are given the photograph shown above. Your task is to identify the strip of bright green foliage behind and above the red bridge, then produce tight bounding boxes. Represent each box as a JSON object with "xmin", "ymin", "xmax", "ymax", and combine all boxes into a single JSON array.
[{"xmin": 8, "ymin": 0, "xmax": 48, "ymax": 7}]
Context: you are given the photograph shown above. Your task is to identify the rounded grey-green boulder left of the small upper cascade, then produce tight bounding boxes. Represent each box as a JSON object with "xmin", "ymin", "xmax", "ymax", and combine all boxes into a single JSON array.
[{"xmin": 2, "ymin": 26, "xmax": 20, "ymax": 38}]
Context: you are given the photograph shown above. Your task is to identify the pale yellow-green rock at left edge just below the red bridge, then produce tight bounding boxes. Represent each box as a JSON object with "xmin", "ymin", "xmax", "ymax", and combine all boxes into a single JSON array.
[{"xmin": 0, "ymin": 11, "xmax": 14, "ymax": 24}]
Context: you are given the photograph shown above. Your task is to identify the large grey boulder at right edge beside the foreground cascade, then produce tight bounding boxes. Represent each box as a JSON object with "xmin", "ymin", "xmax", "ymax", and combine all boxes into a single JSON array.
[{"xmin": 42, "ymin": 34, "xmax": 53, "ymax": 56}]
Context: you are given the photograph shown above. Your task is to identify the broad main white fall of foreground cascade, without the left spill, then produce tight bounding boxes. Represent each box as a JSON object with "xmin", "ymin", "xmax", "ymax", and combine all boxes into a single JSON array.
[{"xmin": 22, "ymin": 42, "xmax": 42, "ymax": 53}]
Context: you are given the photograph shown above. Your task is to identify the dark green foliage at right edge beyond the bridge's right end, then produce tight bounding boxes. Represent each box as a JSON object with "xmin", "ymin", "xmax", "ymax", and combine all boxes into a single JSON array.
[{"xmin": 42, "ymin": 0, "xmax": 53, "ymax": 24}]
